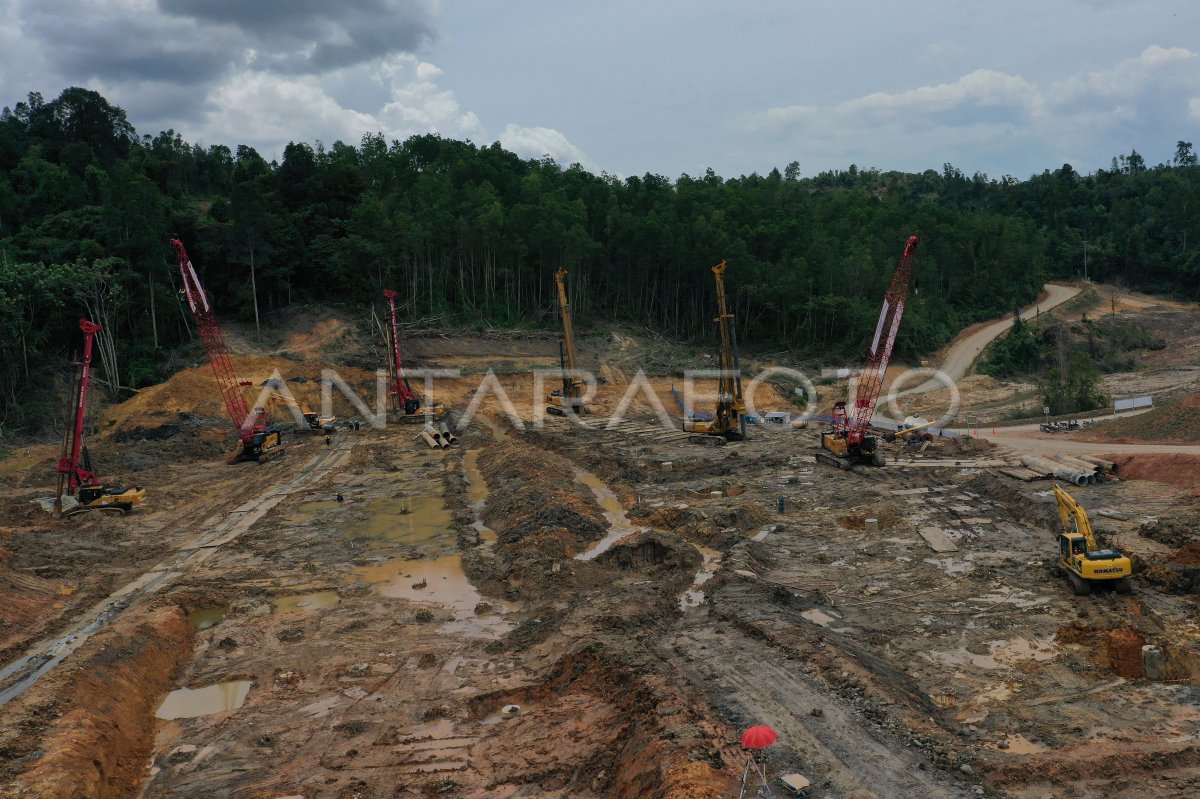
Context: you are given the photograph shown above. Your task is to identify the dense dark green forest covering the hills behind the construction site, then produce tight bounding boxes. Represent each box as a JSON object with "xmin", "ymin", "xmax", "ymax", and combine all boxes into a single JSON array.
[{"xmin": 0, "ymin": 88, "xmax": 1200, "ymax": 435}]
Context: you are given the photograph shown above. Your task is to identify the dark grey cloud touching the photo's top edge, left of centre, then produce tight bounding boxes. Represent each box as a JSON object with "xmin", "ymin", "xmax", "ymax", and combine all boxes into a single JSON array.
[{"xmin": 158, "ymin": 0, "xmax": 437, "ymax": 73}]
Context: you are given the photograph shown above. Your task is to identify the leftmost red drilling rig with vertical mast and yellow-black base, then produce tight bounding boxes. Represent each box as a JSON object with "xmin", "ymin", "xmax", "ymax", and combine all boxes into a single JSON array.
[{"xmin": 54, "ymin": 319, "xmax": 146, "ymax": 516}]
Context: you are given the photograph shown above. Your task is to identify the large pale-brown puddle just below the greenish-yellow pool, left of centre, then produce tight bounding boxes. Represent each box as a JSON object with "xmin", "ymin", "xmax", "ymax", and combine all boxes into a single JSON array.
[{"xmin": 354, "ymin": 554, "xmax": 514, "ymax": 638}]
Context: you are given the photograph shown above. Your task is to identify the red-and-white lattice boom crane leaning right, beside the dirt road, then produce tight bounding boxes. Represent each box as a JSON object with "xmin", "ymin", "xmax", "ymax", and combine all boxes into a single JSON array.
[{"xmin": 817, "ymin": 236, "xmax": 920, "ymax": 469}]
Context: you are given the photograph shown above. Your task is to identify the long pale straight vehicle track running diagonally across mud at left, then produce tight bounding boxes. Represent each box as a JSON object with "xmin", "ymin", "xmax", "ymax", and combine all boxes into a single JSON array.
[{"xmin": 0, "ymin": 434, "xmax": 354, "ymax": 708}]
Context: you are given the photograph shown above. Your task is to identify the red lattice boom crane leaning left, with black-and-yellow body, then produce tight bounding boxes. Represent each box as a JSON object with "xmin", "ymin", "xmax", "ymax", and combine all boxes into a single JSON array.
[{"xmin": 170, "ymin": 239, "xmax": 283, "ymax": 463}]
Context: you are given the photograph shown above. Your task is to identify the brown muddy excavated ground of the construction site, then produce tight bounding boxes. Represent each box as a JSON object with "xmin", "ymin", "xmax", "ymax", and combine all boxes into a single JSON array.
[{"xmin": 0, "ymin": 314, "xmax": 1200, "ymax": 799}]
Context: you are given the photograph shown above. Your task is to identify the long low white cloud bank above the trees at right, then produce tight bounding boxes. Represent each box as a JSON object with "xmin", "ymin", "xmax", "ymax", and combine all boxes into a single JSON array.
[{"xmin": 736, "ymin": 44, "xmax": 1200, "ymax": 173}]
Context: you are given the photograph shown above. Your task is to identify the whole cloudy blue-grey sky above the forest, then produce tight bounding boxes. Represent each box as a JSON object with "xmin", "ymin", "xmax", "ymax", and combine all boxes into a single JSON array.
[{"xmin": 0, "ymin": 0, "xmax": 1200, "ymax": 178}]
